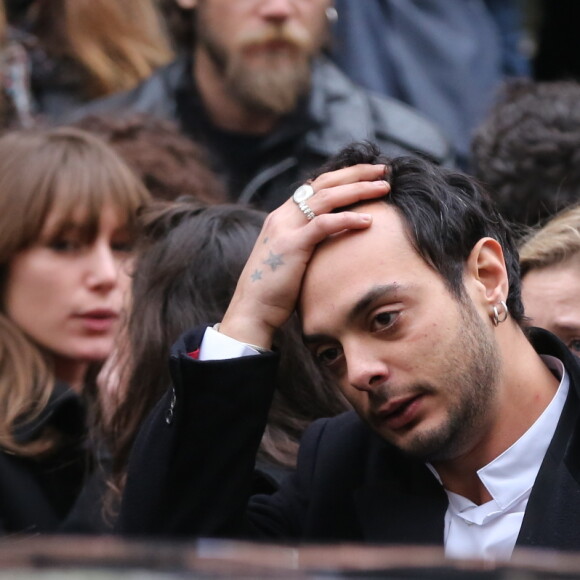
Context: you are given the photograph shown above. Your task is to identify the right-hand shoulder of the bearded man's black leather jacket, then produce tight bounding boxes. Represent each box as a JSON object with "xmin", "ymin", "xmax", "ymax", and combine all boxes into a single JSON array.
[{"xmin": 311, "ymin": 58, "xmax": 453, "ymax": 165}]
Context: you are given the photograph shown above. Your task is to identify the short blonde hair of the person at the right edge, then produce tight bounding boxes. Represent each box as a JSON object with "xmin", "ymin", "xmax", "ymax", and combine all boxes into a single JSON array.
[{"xmin": 520, "ymin": 205, "xmax": 580, "ymax": 277}]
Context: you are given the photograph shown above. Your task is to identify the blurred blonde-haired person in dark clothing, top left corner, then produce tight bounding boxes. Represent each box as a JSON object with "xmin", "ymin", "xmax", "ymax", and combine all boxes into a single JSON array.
[{"xmin": 3, "ymin": 0, "xmax": 172, "ymax": 124}]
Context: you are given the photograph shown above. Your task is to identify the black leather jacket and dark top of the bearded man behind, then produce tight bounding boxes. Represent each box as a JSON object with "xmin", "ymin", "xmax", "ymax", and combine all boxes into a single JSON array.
[{"xmin": 75, "ymin": 57, "xmax": 452, "ymax": 211}]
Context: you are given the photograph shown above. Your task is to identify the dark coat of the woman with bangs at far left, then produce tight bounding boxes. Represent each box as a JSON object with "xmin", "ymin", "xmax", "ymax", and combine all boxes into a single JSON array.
[{"xmin": 0, "ymin": 384, "xmax": 106, "ymax": 535}]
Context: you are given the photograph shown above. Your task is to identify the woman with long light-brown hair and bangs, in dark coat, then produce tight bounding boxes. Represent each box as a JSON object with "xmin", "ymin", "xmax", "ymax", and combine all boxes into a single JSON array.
[{"xmin": 0, "ymin": 128, "xmax": 149, "ymax": 533}]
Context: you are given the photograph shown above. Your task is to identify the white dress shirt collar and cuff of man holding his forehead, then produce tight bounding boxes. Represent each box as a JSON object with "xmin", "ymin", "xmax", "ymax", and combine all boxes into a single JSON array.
[{"xmin": 199, "ymin": 328, "xmax": 570, "ymax": 561}]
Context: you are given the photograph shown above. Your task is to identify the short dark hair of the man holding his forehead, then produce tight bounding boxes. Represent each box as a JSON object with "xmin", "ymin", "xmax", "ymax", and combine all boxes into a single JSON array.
[{"xmin": 317, "ymin": 143, "xmax": 524, "ymax": 324}]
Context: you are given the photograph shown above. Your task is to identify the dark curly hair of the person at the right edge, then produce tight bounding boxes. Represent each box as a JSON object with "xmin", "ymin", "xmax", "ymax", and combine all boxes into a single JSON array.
[{"xmin": 472, "ymin": 80, "xmax": 580, "ymax": 226}]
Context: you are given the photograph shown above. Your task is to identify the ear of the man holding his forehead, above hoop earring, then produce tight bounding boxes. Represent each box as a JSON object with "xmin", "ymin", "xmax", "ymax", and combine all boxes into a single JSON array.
[{"xmin": 465, "ymin": 238, "xmax": 509, "ymax": 305}]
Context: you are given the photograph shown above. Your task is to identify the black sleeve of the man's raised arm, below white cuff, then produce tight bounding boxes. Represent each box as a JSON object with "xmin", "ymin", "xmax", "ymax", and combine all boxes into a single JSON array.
[{"xmin": 117, "ymin": 329, "xmax": 278, "ymax": 537}]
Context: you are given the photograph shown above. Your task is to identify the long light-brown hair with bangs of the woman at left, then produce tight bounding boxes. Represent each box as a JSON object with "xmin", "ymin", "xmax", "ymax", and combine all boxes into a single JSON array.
[{"xmin": 0, "ymin": 128, "xmax": 149, "ymax": 456}]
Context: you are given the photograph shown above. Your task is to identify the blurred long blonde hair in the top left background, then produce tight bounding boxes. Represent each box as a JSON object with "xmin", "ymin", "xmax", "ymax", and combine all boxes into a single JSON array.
[{"xmin": 34, "ymin": 0, "xmax": 172, "ymax": 98}]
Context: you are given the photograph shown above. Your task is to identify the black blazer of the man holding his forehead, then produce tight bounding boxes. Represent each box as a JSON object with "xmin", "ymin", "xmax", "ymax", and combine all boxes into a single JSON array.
[{"xmin": 118, "ymin": 329, "xmax": 580, "ymax": 549}]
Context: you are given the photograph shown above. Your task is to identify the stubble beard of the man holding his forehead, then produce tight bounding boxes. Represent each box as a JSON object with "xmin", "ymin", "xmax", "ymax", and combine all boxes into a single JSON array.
[{"xmin": 379, "ymin": 297, "xmax": 501, "ymax": 462}]
